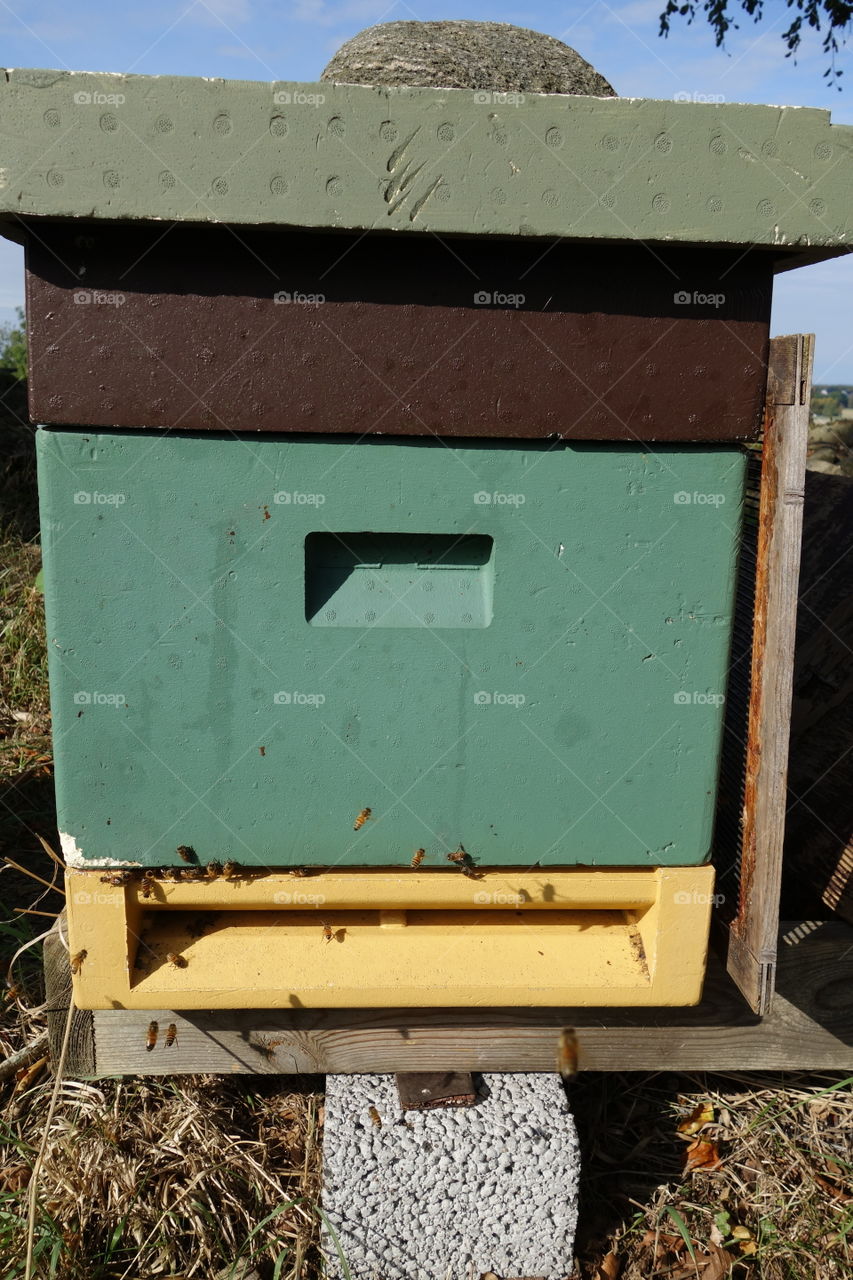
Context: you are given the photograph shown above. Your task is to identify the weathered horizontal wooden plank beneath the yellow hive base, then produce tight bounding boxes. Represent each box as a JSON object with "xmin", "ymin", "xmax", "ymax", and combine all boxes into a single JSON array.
[{"xmin": 87, "ymin": 922, "xmax": 853, "ymax": 1075}]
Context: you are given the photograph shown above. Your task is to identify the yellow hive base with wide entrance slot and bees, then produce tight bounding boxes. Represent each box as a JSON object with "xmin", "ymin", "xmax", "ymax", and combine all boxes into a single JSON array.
[{"xmin": 67, "ymin": 867, "xmax": 713, "ymax": 1009}]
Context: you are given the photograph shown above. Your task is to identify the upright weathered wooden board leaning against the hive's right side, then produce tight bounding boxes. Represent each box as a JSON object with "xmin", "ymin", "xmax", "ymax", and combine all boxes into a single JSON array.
[{"xmin": 727, "ymin": 334, "xmax": 813, "ymax": 1012}]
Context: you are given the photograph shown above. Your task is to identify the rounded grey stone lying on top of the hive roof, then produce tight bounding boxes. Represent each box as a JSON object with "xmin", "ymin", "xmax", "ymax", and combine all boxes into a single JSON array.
[{"xmin": 321, "ymin": 22, "xmax": 615, "ymax": 97}]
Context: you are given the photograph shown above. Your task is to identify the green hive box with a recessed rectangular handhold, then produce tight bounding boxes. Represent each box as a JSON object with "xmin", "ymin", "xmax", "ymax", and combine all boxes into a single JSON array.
[{"xmin": 38, "ymin": 430, "xmax": 744, "ymax": 867}]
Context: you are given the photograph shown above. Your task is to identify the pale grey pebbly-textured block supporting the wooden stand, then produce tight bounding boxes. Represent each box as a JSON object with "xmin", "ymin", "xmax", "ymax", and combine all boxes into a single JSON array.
[{"xmin": 323, "ymin": 1073, "xmax": 580, "ymax": 1280}]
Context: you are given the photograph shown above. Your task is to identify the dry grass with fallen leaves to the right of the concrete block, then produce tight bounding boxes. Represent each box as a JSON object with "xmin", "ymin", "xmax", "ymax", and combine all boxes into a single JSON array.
[{"xmin": 563, "ymin": 1073, "xmax": 853, "ymax": 1280}]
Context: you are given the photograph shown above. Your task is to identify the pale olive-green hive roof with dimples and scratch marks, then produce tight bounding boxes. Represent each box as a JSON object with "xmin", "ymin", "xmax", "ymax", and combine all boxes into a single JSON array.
[{"xmin": 0, "ymin": 70, "xmax": 853, "ymax": 268}]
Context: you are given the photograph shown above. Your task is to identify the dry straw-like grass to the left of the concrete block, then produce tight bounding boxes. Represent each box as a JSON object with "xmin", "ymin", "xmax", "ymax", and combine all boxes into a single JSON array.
[{"xmin": 0, "ymin": 1076, "xmax": 319, "ymax": 1280}]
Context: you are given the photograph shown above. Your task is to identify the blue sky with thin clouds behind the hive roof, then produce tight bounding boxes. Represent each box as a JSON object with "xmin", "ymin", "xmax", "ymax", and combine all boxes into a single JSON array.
[{"xmin": 0, "ymin": 0, "xmax": 853, "ymax": 383}]
